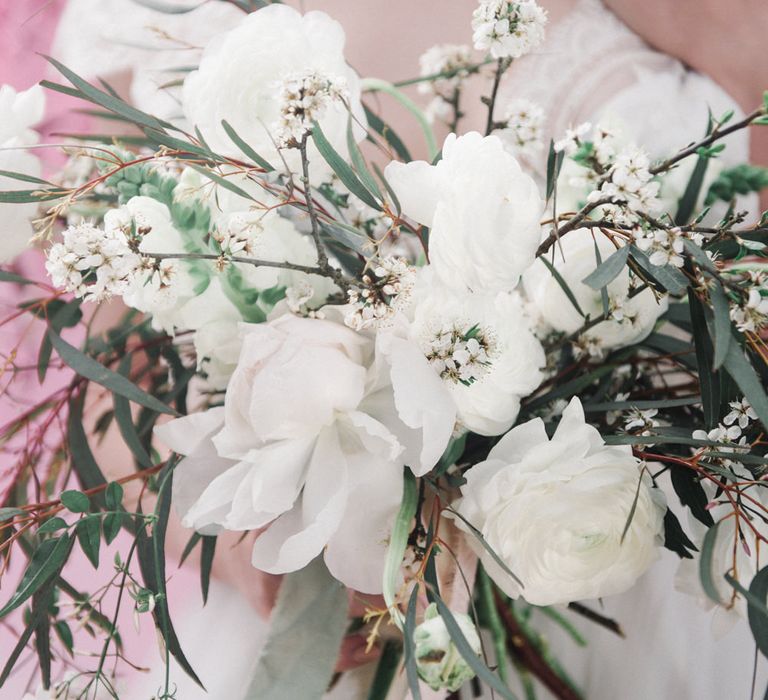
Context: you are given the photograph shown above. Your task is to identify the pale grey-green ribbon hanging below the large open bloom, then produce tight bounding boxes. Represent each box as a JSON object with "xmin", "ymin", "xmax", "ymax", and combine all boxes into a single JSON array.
[{"xmin": 243, "ymin": 557, "xmax": 348, "ymax": 700}]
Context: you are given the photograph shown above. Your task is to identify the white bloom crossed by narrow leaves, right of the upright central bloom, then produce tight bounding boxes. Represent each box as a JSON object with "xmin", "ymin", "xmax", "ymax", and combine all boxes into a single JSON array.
[{"xmin": 523, "ymin": 229, "xmax": 668, "ymax": 351}]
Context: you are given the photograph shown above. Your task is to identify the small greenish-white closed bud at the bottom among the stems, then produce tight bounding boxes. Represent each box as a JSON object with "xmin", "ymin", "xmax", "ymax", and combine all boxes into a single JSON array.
[{"xmin": 413, "ymin": 603, "xmax": 482, "ymax": 692}]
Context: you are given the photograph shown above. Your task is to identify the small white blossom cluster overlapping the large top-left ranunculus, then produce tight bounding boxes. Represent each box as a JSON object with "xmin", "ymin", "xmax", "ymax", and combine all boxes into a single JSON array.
[{"xmin": 277, "ymin": 70, "xmax": 348, "ymax": 146}]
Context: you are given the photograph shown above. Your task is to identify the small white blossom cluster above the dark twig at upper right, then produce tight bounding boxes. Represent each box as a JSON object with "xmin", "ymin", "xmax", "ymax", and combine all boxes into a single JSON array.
[{"xmin": 587, "ymin": 146, "xmax": 661, "ymax": 212}]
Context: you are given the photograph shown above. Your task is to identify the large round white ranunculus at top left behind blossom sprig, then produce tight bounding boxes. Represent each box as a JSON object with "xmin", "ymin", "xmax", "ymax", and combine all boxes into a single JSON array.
[{"xmin": 183, "ymin": 4, "xmax": 365, "ymax": 176}]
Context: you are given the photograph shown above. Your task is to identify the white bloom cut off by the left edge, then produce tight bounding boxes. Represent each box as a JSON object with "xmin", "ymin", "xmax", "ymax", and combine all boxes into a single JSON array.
[{"xmin": 0, "ymin": 85, "xmax": 45, "ymax": 262}]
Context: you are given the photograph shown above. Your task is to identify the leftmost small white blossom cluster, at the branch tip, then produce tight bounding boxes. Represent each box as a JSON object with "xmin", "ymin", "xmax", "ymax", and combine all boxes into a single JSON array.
[{"xmin": 45, "ymin": 223, "xmax": 142, "ymax": 301}]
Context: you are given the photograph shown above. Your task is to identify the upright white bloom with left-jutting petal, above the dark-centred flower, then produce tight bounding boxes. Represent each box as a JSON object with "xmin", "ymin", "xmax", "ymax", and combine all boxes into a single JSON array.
[{"xmin": 385, "ymin": 132, "xmax": 544, "ymax": 293}]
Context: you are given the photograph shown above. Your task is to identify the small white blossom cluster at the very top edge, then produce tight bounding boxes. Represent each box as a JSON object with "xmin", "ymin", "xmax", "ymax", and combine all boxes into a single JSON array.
[{"xmin": 472, "ymin": 0, "xmax": 547, "ymax": 58}]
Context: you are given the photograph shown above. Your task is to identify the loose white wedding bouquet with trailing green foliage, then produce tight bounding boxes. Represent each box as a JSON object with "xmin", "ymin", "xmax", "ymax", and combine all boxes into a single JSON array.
[{"xmin": 0, "ymin": 0, "xmax": 768, "ymax": 699}]
